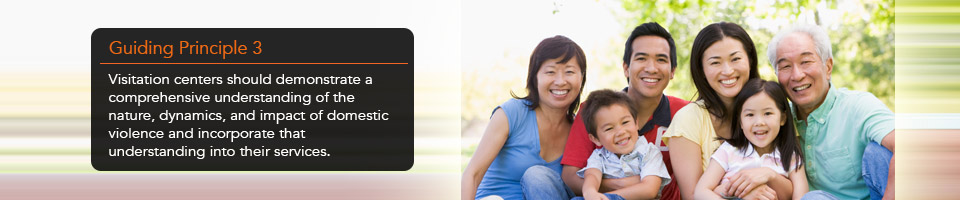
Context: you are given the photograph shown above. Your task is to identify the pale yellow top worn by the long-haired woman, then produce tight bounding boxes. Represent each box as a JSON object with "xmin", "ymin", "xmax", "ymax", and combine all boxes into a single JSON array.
[{"xmin": 663, "ymin": 101, "xmax": 723, "ymax": 171}]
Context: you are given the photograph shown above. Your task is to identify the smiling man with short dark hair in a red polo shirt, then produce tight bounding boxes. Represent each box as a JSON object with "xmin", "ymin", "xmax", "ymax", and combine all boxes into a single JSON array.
[{"xmin": 560, "ymin": 22, "xmax": 689, "ymax": 199}]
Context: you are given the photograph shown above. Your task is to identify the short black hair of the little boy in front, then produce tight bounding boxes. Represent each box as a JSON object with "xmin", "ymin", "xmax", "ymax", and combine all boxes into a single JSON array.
[{"xmin": 580, "ymin": 89, "xmax": 637, "ymax": 137}]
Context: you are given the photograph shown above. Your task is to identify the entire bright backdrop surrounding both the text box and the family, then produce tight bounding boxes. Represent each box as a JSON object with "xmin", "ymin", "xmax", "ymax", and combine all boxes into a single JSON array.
[{"xmin": 0, "ymin": 0, "xmax": 960, "ymax": 199}]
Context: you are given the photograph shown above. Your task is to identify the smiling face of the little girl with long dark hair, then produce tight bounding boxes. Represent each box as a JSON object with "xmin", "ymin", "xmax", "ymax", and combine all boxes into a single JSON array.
[{"xmin": 740, "ymin": 92, "xmax": 787, "ymax": 155}]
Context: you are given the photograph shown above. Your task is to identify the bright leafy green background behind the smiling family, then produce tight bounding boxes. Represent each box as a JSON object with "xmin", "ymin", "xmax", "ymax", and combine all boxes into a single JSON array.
[{"xmin": 461, "ymin": 0, "xmax": 896, "ymax": 145}]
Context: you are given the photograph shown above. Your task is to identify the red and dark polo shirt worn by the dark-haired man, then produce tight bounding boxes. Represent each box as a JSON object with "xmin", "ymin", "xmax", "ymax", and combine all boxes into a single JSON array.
[{"xmin": 560, "ymin": 92, "xmax": 690, "ymax": 199}]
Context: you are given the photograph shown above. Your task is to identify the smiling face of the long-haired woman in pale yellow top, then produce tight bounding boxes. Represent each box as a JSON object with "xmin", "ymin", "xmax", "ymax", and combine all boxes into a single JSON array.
[{"xmin": 702, "ymin": 37, "xmax": 750, "ymax": 102}]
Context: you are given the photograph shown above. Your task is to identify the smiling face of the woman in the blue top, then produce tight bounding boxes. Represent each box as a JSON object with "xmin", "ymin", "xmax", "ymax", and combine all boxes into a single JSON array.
[{"xmin": 537, "ymin": 57, "xmax": 583, "ymax": 110}]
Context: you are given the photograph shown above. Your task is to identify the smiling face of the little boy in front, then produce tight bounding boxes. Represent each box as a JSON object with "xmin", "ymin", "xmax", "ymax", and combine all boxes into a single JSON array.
[{"xmin": 590, "ymin": 104, "xmax": 639, "ymax": 155}]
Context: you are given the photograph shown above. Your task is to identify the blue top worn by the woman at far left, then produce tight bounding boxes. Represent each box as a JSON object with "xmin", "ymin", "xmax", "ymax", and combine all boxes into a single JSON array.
[{"xmin": 475, "ymin": 99, "xmax": 563, "ymax": 199}]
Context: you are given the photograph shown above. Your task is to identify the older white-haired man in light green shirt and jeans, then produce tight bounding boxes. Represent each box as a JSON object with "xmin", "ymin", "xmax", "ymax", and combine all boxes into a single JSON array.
[{"xmin": 767, "ymin": 25, "xmax": 896, "ymax": 199}]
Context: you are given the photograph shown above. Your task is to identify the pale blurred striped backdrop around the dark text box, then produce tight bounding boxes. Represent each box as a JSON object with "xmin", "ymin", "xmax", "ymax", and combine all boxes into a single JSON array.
[{"xmin": 0, "ymin": 0, "xmax": 460, "ymax": 199}]
